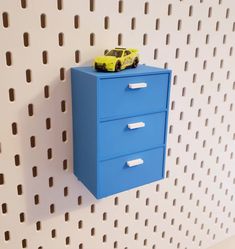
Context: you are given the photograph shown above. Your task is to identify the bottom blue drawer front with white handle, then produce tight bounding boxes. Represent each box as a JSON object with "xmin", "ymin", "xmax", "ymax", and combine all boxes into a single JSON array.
[{"xmin": 98, "ymin": 147, "xmax": 165, "ymax": 198}]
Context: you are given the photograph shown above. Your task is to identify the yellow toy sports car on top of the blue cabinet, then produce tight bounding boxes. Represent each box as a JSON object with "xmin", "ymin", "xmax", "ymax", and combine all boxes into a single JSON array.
[{"xmin": 94, "ymin": 48, "xmax": 139, "ymax": 72}]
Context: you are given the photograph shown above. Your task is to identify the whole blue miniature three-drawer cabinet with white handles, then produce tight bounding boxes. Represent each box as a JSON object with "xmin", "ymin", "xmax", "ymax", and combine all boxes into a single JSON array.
[{"xmin": 71, "ymin": 65, "xmax": 171, "ymax": 199}]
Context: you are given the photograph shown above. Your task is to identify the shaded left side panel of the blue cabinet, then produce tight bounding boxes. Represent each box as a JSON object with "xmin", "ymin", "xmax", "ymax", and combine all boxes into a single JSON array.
[{"xmin": 71, "ymin": 69, "xmax": 97, "ymax": 195}]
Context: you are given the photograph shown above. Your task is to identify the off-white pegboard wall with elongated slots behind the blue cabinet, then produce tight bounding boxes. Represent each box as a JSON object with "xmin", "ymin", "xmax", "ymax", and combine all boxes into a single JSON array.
[{"xmin": 0, "ymin": 0, "xmax": 235, "ymax": 249}]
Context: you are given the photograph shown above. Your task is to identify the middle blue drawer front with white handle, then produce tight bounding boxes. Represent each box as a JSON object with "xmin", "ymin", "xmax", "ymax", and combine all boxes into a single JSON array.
[{"xmin": 99, "ymin": 112, "xmax": 166, "ymax": 159}]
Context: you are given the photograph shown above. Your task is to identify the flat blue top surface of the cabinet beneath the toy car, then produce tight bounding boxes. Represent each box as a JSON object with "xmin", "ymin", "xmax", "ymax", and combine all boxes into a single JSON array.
[{"xmin": 72, "ymin": 65, "xmax": 171, "ymax": 78}]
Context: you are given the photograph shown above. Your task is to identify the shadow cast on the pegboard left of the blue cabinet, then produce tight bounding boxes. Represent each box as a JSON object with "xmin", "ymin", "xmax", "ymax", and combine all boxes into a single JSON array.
[{"xmin": 18, "ymin": 66, "xmax": 96, "ymax": 223}]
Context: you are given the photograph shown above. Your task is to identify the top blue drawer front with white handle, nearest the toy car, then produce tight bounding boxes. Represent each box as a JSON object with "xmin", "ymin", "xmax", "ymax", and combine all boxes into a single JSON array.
[{"xmin": 99, "ymin": 74, "xmax": 169, "ymax": 119}]
